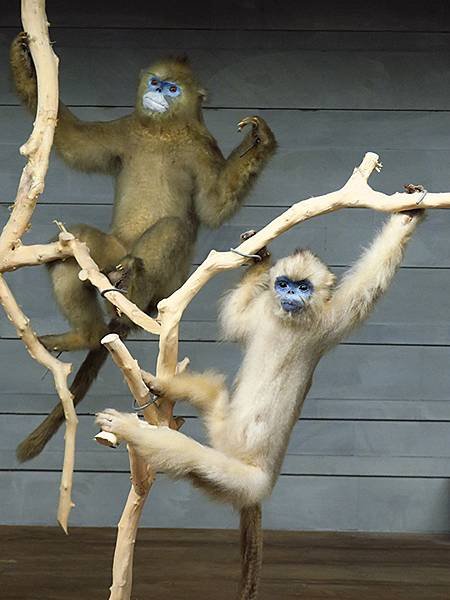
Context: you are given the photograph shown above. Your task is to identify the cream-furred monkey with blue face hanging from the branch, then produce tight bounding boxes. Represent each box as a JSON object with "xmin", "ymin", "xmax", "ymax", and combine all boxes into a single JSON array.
[{"xmin": 96, "ymin": 210, "xmax": 424, "ymax": 600}]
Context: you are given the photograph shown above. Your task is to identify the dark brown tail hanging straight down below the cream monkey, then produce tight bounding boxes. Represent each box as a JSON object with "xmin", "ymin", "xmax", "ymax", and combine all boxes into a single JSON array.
[{"xmin": 238, "ymin": 504, "xmax": 263, "ymax": 600}]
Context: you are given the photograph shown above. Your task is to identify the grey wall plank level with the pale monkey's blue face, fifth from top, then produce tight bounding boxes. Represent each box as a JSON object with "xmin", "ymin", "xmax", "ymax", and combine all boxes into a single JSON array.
[{"xmin": 0, "ymin": 253, "xmax": 450, "ymax": 346}]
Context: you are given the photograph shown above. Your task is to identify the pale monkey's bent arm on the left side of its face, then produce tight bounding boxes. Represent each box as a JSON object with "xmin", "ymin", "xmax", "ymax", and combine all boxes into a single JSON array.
[{"xmin": 220, "ymin": 257, "xmax": 272, "ymax": 342}]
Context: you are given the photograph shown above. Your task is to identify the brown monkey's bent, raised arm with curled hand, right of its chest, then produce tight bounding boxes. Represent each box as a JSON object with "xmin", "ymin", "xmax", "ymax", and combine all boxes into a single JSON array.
[{"xmin": 194, "ymin": 117, "xmax": 276, "ymax": 227}]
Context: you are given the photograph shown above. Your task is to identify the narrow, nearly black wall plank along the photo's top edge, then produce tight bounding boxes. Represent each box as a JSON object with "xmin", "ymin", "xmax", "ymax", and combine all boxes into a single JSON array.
[{"xmin": 2, "ymin": 0, "xmax": 450, "ymax": 32}]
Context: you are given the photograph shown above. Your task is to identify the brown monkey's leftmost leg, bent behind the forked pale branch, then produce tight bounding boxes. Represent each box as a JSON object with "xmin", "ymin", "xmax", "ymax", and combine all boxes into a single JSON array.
[{"xmin": 40, "ymin": 225, "xmax": 124, "ymax": 351}]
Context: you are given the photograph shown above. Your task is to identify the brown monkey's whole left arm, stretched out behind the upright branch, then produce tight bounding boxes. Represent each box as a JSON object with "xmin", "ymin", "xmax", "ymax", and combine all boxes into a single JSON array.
[{"xmin": 10, "ymin": 33, "xmax": 122, "ymax": 173}]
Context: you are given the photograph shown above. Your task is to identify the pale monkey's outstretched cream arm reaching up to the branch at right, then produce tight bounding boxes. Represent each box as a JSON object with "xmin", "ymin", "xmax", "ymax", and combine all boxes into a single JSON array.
[{"xmin": 327, "ymin": 210, "xmax": 424, "ymax": 343}]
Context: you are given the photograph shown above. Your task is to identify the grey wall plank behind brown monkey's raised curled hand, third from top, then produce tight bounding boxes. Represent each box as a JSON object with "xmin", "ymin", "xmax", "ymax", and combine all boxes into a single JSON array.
[{"xmin": 4, "ymin": 106, "xmax": 450, "ymax": 206}]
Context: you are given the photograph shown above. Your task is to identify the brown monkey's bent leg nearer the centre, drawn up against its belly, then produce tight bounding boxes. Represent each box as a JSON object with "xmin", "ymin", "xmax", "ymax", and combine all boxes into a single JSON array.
[{"xmin": 111, "ymin": 217, "xmax": 195, "ymax": 310}]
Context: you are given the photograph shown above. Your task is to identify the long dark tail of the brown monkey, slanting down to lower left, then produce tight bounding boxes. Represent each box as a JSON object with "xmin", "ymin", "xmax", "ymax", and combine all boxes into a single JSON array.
[{"xmin": 16, "ymin": 319, "xmax": 129, "ymax": 462}]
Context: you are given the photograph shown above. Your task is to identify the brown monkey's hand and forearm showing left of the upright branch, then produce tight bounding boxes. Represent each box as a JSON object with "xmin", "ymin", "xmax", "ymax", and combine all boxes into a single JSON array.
[{"xmin": 9, "ymin": 31, "xmax": 37, "ymax": 109}]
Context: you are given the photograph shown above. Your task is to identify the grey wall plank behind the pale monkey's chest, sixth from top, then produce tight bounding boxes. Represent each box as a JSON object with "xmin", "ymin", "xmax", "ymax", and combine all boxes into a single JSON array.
[{"xmin": 0, "ymin": 340, "xmax": 450, "ymax": 418}]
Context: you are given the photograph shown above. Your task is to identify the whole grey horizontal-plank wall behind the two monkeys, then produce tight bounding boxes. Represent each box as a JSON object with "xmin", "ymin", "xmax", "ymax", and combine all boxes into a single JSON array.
[{"xmin": 0, "ymin": 0, "xmax": 450, "ymax": 531}]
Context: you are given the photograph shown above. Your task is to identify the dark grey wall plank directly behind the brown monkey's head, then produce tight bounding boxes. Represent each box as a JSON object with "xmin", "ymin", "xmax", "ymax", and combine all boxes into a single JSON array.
[{"xmin": 0, "ymin": 28, "xmax": 450, "ymax": 110}]
